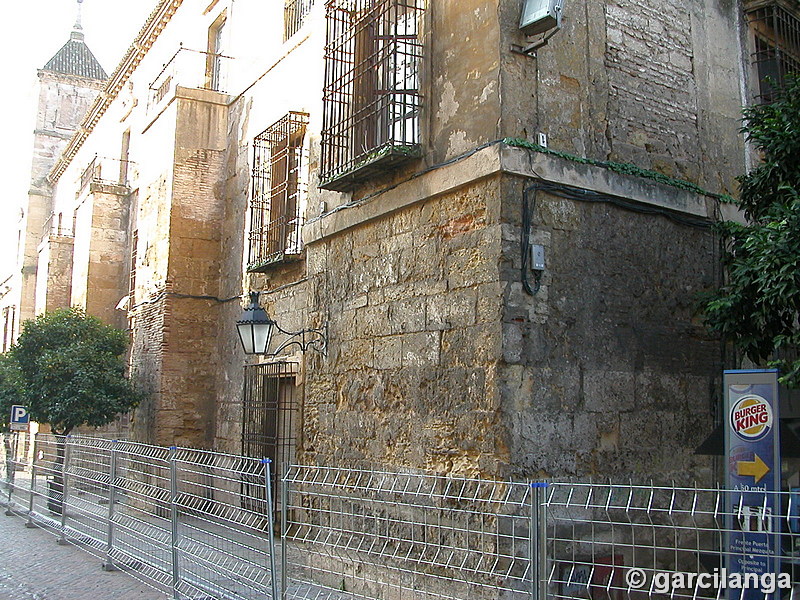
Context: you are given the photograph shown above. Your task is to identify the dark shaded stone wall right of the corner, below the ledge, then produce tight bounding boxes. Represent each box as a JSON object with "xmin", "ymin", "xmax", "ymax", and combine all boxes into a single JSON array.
[{"xmin": 499, "ymin": 172, "xmax": 722, "ymax": 479}]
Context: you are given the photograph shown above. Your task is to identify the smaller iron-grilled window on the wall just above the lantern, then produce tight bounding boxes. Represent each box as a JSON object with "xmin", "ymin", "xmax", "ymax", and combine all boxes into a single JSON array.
[{"xmin": 248, "ymin": 112, "xmax": 308, "ymax": 272}]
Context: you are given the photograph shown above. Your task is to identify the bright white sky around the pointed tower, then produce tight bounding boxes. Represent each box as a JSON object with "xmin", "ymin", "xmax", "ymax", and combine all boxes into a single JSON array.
[{"xmin": 0, "ymin": 0, "xmax": 157, "ymax": 279}]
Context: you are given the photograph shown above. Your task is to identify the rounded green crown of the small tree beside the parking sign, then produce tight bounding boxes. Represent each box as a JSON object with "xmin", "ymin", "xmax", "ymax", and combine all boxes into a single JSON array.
[{"xmin": 9, "ymin": 308, "xmax": 139, "ymax": 435}]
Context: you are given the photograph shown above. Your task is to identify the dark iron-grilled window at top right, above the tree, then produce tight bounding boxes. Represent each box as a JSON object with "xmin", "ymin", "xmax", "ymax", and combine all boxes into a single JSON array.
[{"xmin": 747, "ymin": 1, "xmax": 800, "ymax": 102}]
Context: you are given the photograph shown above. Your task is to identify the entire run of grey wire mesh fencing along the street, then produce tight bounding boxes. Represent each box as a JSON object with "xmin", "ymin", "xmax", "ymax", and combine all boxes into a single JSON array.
[{"xmin": 4, "ymin": 436, "xmax": 800, "ymax": 600}]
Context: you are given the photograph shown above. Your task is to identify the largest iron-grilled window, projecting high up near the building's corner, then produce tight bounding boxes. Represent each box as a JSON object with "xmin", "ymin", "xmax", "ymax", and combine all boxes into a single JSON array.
[{"xmin": 320, "ymin": 0, "xmax": 424, "ymax": 191}]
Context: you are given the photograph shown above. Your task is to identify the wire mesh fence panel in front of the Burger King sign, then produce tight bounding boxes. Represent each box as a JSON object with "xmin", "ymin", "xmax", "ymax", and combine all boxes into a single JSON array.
[{"xmin": 546, "ymin": 483, "xmax": 800, "ymax": 600}]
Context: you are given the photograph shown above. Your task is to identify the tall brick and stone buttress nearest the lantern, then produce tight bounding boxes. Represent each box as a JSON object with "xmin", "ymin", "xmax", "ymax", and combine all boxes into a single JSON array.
[{"xmin": 132, "ymin": 88, "xmax": 227, "ymax": 447}]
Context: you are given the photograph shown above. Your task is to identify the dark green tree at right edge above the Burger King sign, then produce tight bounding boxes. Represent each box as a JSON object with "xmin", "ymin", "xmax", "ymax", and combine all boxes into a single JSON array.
[{"xmin": 701, "ymin": 77, "xmax": 800, "ymax": 387}]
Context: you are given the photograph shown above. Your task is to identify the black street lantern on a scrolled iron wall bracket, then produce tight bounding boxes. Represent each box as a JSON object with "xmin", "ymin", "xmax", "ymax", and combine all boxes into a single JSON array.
[{"xmin": 236, "ymin": 292, "xmax": 328, "ymax": 356}]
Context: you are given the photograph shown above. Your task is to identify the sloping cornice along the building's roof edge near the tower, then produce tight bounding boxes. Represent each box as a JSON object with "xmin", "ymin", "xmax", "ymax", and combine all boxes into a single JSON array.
[{"xmin": 47, "ymin": 0, "xmax": 183, "ymax": 183}]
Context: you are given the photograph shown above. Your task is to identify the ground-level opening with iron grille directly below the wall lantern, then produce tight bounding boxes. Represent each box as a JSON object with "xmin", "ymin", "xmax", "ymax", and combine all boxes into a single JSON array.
[{"xmin": 242, "ymin": 362, "xmax": 300, "ymax": 510}]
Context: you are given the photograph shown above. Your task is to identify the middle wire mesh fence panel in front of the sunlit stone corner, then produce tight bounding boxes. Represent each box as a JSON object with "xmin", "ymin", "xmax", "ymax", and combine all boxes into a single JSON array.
[{"xmin": 282, "ymin": 466, "xmax": 532, "ymax": 599}]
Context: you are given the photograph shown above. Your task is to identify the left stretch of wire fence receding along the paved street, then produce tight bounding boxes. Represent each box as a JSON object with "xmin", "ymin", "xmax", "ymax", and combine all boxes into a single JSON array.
[{"xmin": 5, "ymin": 435, "xmax": 277, "ymax": 600}]
